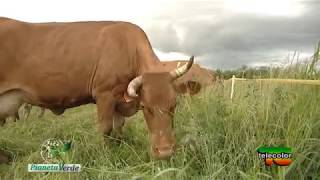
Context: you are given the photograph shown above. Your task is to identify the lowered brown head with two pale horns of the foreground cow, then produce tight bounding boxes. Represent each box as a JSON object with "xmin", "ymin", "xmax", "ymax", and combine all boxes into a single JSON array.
[{"xmin": 127, "ymin": 56, "xmax": 194, "ymax": 159}]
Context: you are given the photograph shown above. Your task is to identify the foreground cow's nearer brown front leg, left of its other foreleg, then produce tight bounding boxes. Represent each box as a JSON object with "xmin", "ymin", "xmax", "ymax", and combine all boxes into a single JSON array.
[{"xmin": 96, "ymin": 93, "xmax": 115, "ymax": 138}]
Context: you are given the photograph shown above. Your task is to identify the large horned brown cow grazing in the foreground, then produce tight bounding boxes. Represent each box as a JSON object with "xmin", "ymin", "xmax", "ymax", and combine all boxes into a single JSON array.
[{"xmin": 0, "ymin": 18, "xmax": 193, "ymax": 159}]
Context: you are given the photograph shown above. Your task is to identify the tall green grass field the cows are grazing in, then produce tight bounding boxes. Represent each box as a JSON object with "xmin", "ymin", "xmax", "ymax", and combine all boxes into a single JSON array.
[{"xmin": 0, "ymin": 81, "xmax": 320, "ymax": 180}]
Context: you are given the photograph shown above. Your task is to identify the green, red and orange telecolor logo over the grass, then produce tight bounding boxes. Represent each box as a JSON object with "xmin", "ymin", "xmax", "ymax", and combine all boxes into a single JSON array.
[{"xmin": 257, "ymin": 146, "xmax": 292, "ymax": 166}]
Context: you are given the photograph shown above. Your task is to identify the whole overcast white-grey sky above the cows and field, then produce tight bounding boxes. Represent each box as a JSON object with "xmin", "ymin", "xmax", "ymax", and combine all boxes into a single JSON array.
[{"xmin": 0, "ymin": 0, "xmax": 320, "ymax": 69}]
